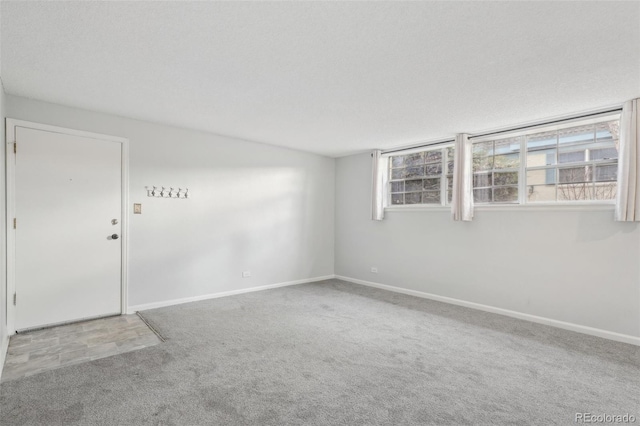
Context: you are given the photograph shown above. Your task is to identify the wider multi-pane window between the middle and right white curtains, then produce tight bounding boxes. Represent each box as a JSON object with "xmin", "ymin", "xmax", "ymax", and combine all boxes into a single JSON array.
[{"xmin": 472, "ymin": 114, "xmax": 619, "ymax": 204}]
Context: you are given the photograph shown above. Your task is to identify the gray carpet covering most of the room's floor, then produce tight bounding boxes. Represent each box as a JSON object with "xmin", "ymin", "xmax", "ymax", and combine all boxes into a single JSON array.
[{"xmin": 0, "ymin": 280, "xmax": 640, "ymax": 425}]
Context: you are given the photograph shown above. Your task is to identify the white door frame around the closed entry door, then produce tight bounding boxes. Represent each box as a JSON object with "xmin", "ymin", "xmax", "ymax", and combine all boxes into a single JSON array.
[{"xmin": 5, "ymin": 118, "xmax": 129, "ymax": 335}]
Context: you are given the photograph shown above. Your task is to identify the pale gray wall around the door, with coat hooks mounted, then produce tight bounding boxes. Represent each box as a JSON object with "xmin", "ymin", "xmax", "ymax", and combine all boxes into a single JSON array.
[{"xmin": 6, "ymin": 96, "xmax": 335, "ymax": 306}]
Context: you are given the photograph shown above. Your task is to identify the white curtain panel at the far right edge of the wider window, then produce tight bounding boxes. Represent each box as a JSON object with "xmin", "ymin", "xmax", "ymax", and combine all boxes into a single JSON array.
[{"xmin": 615, "ymin": 99, "xmax": 640, "ymax": 222}]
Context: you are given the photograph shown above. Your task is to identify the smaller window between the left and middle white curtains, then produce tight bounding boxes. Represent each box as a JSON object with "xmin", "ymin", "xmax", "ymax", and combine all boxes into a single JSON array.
[{"xmin": 389, "ymin": 146, "xmax": 453, "ymax": 206}]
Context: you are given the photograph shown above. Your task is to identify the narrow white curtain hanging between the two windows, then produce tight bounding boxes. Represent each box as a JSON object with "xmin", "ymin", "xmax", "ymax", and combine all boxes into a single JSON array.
[{"xmin": 451, "ymin": 133, "xmax": 473, "ymax": 221}]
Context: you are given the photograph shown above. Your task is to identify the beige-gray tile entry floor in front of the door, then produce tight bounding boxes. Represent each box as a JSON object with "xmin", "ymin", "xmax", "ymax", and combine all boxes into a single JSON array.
[{"xmin": 2, "ymin": 314, "xmax": 161, "ymax": 382}]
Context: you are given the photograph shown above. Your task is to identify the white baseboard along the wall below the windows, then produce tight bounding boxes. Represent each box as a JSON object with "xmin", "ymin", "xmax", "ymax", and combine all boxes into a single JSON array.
[{"xmin": 335, "ymin": 275, "xmax": 640, "ymax": 346}]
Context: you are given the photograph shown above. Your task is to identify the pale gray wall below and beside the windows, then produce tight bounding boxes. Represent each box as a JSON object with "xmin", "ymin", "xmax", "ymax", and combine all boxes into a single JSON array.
[{"xmin": 336, "ymin": 154, "xmax": 640, "ymax": 337}]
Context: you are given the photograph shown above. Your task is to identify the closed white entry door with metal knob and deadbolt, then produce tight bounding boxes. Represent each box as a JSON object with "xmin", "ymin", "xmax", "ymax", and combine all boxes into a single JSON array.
[{"xmin": 15, "ymin": 127, "xmax": 122, "ymax": 330}]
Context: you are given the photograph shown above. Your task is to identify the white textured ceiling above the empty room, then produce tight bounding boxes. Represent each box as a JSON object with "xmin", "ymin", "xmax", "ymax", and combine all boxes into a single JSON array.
[{"xmin": 1, "ymin": 1, "xmax": 640, "ymax": 156}]
